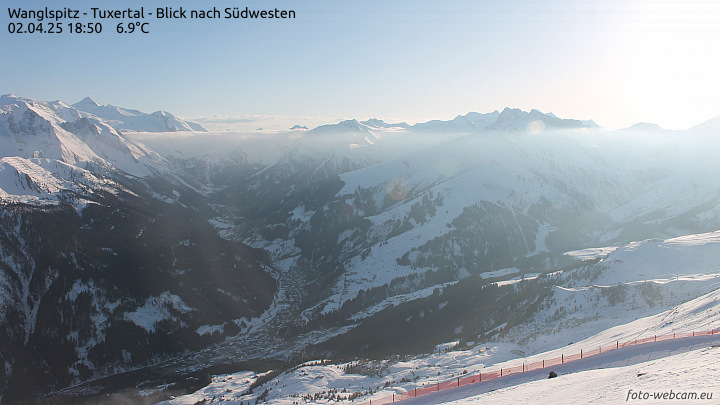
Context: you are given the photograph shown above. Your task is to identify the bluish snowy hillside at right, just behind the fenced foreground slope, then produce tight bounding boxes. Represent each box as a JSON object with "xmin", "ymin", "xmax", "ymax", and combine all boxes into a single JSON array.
[{"xmin": 503, "ymin": 232, "xmax": 720, "ymax": 353}]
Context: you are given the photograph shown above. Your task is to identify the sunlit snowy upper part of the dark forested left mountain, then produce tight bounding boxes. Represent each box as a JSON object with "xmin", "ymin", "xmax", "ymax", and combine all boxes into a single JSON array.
[{"xmin": 0, "ymin": 95, "xmax": 174, "ymax": 202}]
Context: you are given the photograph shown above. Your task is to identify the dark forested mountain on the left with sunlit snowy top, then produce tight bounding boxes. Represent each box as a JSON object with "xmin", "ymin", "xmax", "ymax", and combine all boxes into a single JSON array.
[{"xmin": 0, "ymin": 95, "xmax": 275, "ymax": 400}]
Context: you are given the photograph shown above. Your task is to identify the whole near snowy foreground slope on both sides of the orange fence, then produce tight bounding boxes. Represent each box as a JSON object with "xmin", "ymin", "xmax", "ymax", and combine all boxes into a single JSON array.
[{"xmin": 160, "ymin": 280, "xmax": 720, "ymax": 404}]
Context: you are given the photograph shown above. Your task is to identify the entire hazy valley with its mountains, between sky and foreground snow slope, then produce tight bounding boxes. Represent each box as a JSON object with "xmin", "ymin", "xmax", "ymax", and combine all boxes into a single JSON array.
[{"xmin": 0, "ymin": 95, "xmax": 720, "ymax": 403}]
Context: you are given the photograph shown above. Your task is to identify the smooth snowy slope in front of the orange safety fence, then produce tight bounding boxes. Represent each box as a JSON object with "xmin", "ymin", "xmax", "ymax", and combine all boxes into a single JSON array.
[{"xmin": 402, "ymin": 337, "xmax": 720, "ymax": 405}]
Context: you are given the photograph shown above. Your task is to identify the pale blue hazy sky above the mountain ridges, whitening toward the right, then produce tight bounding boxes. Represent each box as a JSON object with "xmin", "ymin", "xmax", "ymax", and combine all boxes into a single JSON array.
[{"xmin": 0, "ymin": 0, "xmax": 720, "ymax": 129}]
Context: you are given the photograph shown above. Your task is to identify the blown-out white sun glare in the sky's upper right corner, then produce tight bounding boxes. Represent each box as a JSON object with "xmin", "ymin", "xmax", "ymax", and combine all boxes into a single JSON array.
[{"xmin": 615, "ymin": 1, "xmax": 720, "ymax": 129}]
